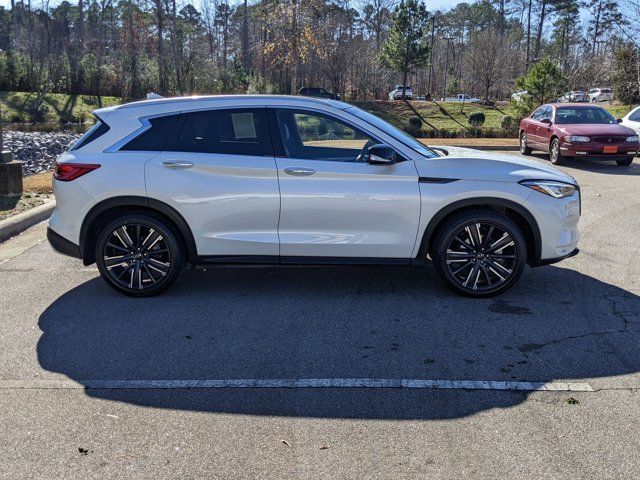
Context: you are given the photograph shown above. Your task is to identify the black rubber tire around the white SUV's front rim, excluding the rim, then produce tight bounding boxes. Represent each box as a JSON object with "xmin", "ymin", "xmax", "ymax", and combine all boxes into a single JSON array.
[{"xmin": 433, "ymin": 212, "xmax": 527, "ymax": 297}]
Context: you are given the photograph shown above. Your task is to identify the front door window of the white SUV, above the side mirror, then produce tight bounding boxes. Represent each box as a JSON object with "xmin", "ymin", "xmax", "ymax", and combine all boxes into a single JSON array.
[{"xmin": 276, "ymin": 109, "xmax": 378, "ymax": 162}]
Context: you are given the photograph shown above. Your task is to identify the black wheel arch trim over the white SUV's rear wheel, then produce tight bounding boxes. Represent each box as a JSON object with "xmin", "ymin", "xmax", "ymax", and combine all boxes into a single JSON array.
[{"xmin": 80, "ymin": 196, "xmax": 198, "ymax": 265}]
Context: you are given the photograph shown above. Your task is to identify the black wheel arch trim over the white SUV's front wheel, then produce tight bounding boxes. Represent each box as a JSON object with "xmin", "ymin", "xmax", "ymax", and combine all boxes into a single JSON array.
[{"xmin": 418, "ymin": 197, "xmax": 542, "ymax": 266}]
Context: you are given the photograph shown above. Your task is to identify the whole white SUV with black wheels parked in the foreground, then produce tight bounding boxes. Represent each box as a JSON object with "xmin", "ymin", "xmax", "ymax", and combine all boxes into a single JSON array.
[{"xmin": 48, "ymin": 96, "xmax": 580, "ymax": 296}]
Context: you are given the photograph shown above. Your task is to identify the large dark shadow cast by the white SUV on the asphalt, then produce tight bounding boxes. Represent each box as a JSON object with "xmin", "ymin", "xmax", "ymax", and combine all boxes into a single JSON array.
[{"xmin": 37, "ymin": 266, "xmax": 640, "ymax": 419}]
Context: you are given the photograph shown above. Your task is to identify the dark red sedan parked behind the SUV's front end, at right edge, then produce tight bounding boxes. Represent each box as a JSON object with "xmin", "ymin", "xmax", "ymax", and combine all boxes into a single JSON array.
[{"xmin": 520, "ymin": 103, "xmax": 640, "ymax": 166}]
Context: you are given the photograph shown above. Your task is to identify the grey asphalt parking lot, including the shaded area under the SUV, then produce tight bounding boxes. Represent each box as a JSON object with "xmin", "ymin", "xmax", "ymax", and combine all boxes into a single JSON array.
[{"xmin": 0, "ymin": 153, "xmax": 640, "ymax": 479}]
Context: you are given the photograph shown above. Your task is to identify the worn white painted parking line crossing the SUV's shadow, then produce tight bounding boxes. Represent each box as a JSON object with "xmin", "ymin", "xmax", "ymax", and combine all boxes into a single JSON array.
[{"xmin": 0, "ymin": 378, "xmax": 593, "ymax": 392}]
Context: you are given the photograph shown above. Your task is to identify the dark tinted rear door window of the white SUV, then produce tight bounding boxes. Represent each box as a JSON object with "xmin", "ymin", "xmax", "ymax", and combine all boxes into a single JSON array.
[{"xmin": 165, "ymin": 108, "xmax": 273, "ymax": 156}]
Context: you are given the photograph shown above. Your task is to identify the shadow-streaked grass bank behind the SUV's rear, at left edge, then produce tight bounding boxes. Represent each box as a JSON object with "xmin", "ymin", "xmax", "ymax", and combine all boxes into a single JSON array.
[{"xmin": 0, "ymin": 92, "xmax": 121, "ymax": 123}]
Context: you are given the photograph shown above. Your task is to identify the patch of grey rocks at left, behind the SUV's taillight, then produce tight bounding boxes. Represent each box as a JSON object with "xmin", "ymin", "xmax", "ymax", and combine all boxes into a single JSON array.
[{"xmin": 3, "ymin": 131, "xmax": 80, "ymax": 176}]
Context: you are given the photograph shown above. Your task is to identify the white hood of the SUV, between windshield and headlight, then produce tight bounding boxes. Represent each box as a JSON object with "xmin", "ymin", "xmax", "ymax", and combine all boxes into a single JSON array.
[{"xmin": 416, "ymin": 145, "xmax": 576, "ymax": 183}]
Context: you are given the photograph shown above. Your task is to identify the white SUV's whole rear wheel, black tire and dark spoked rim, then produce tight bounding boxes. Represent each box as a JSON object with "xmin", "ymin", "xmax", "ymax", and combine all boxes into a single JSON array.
[{"xmin": 95, "ymin": 212, "xmax": 184, "ymax": 297}]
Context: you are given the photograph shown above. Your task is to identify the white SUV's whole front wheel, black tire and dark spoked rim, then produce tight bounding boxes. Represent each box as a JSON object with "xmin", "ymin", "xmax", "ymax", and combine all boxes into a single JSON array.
[{"xmin": 431, "ymin": 210, "xmax": 527, "ymax": 298}]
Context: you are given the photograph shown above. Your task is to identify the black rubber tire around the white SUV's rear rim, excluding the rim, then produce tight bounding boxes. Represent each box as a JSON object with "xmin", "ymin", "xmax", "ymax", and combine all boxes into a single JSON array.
[{"xmin": 95, "ymin": 213, "xmax": 184, "ymax": 297}]
